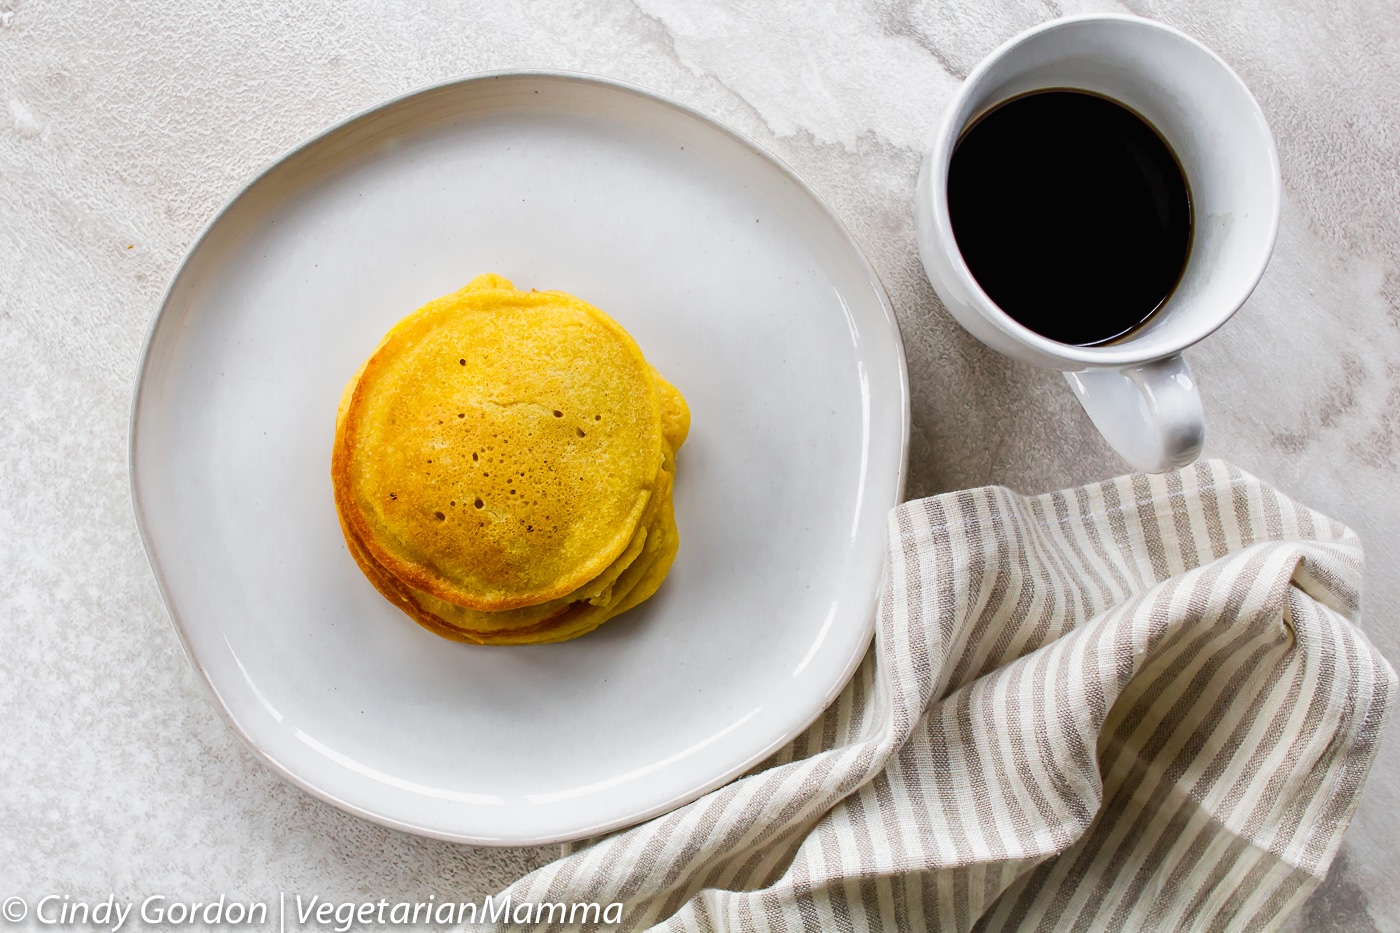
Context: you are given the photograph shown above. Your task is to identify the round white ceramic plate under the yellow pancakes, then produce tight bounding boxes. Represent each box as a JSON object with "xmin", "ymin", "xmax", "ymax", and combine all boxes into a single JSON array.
[{"xmin": 132, "ymin": 73, "xmax": 909, "ymax": 845}]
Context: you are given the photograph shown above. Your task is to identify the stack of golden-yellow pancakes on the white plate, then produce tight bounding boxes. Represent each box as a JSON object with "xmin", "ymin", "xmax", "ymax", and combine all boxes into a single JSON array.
[{"xmin": 330, "ymin": 275, "xmax": 690, "ymax": 644}]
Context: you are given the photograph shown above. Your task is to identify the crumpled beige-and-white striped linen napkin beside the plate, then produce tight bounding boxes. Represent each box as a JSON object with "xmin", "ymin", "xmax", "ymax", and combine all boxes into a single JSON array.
[{"xmin": 473, "ymin": 461, "xmax": 1396, "ymax": 932}]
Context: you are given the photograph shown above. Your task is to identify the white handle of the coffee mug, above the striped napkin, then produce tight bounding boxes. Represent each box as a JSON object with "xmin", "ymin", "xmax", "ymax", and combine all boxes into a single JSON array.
[{"xmin": 1064, "ymin": 353, "xmax": 1205, "ymax": 474}]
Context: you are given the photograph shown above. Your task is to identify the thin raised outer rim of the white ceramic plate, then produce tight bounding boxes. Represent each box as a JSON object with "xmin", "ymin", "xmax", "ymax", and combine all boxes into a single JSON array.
[{"xmin": 126, "ymin": 69, "xmax": 913, "ymax": 848}]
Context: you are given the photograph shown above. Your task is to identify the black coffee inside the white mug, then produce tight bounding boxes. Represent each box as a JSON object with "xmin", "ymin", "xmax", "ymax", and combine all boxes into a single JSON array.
[{"xmin": 948, "ymin": 91, "xmax": 1191, "ymax": 346}]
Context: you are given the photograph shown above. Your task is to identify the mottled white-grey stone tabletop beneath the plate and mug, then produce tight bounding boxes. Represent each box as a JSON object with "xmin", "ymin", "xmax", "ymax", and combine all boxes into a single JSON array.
[{"xmin": 0, "ymin": 0, "xmax": 1400, "ymax": 930}]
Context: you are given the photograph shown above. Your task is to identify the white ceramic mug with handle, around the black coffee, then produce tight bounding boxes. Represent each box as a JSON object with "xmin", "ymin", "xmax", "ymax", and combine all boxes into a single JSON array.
[{"xmin": 916, "ymin": 15, "xmax": 1281, "ymax": 472}]
